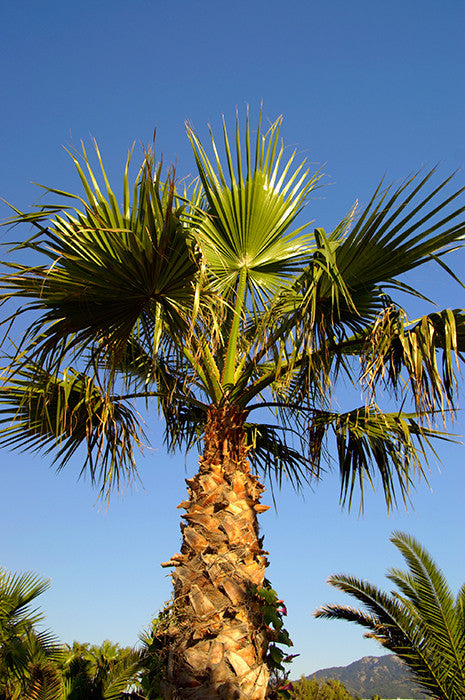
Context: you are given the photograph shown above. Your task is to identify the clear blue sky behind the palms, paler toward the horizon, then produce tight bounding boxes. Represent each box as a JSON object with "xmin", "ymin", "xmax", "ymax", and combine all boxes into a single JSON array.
[{"xmin": 0, "ymin": 0, "xmax": 465, "ymax": 676}]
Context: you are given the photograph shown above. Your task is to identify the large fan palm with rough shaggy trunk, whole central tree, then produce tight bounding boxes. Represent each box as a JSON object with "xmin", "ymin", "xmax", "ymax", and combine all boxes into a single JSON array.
[{"xmin": 1, "ymin": 108, "xmax": 465, "ymax": 700}]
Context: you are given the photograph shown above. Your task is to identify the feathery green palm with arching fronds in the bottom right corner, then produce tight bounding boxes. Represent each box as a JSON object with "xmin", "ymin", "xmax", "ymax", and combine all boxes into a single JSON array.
[{"xmin": 315, "ymin": 532, "xmax": 465, "ymax": 700}]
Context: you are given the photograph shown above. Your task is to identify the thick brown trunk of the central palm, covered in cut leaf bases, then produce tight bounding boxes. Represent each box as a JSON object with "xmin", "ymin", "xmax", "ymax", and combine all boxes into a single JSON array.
[{"xmin": 163, "ymin": 406, "xmax": 269, "ymax": 700}]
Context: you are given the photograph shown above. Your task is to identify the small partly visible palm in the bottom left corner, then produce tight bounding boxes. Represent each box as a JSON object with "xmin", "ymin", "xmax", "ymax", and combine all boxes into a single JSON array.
[{"xmin": 0, "ymin": 569, "xmax": 62, "ymax": 700}]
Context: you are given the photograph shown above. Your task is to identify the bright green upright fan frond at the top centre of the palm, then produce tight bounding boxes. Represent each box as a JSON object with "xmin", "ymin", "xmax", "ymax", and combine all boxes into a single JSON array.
[{"xmin": 187, "ymin": 108, "xmax": 321, "ymax": 301}]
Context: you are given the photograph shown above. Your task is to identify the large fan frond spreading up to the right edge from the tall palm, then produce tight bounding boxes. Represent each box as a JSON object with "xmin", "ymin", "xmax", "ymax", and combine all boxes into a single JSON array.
[{"xmin": 272, "ymin": 171, "xmax": 465, "ymax": 372}]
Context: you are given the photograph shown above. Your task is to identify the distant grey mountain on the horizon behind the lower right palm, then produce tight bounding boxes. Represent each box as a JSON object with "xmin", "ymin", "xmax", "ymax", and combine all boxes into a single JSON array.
[{"xmin": 308, "ymin": 654, "xmax": 426, "ymax": 700}]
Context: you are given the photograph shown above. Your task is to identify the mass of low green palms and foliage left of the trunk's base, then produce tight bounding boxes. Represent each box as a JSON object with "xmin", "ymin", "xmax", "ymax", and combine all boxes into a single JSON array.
[{"xmin": 0, "ymin": 569, "xmax": 143, "ymax": 700}]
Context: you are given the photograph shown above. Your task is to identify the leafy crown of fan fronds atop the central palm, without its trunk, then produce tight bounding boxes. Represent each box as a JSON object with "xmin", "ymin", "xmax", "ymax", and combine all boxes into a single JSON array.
[{"xmin": 2, "ymin": 109, "xmax": 465, "ymax": 505}]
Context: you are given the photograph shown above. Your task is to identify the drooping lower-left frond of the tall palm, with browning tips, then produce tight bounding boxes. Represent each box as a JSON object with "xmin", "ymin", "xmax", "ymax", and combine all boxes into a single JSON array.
[{"xmin": 0, "ymin": 362, "xmax": 142, "ymax": 496}]
